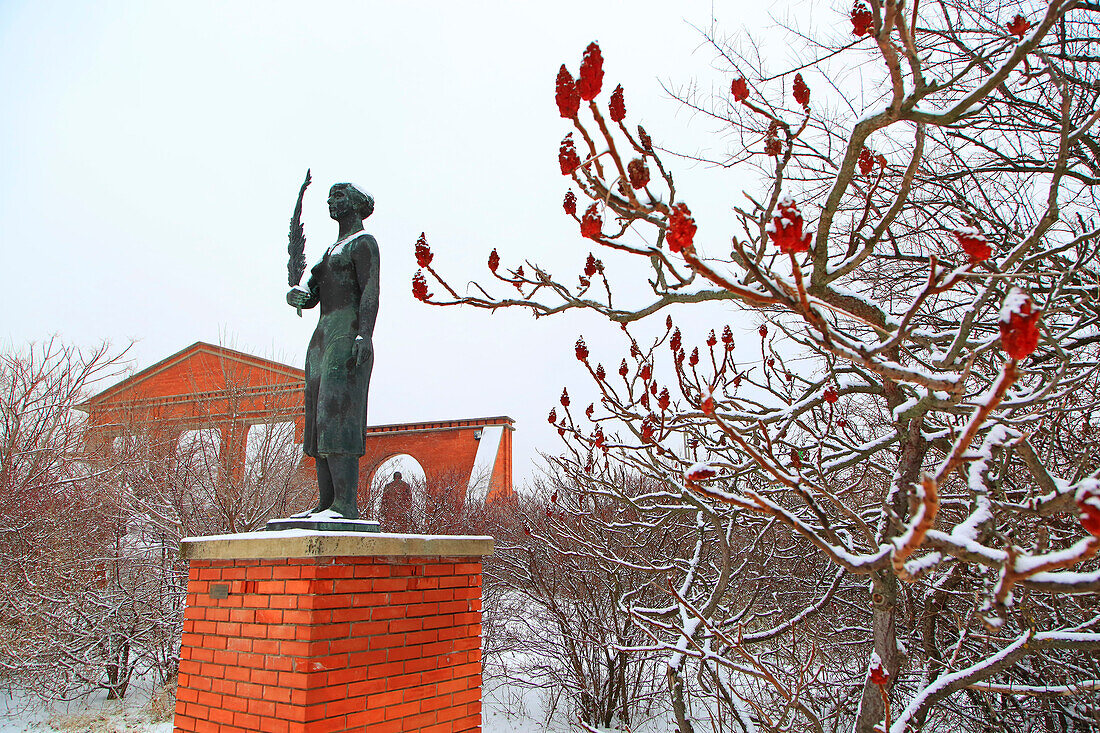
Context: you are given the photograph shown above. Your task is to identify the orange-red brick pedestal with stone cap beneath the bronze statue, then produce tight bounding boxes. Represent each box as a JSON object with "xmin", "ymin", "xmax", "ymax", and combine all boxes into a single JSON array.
[{"xmin": 175, "ymin": 530, "xmax": 493, "ymax": 733}]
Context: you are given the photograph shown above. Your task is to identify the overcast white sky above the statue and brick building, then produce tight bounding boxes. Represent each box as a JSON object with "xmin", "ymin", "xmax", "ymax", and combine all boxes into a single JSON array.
[{"xmin": 0, "ymin": 0, "xmax": 792, "ymax": 484}]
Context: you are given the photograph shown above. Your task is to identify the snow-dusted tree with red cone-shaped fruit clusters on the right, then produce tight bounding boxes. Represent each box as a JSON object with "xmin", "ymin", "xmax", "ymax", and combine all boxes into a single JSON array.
[{"xmin": 413, "ymin": 0, "xmax": 1100, "ymax": 733}]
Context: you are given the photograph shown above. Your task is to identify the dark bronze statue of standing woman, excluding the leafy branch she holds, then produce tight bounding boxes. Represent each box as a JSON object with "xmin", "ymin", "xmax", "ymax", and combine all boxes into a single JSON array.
[{"xmin": 286, "ymin": 183, "xmax": 378, "ymax": 519}]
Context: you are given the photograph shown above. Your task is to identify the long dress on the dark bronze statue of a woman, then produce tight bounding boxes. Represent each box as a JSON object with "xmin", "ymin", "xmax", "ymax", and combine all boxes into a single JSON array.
[{"xmin": 303, "ymin": 232, "xmax": 378, "ymax": 458}]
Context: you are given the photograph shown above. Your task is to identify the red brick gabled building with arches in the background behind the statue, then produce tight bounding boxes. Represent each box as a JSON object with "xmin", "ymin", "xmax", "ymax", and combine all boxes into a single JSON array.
[{"xmin": 78, "ymin": 341, "xmax": 515, "ymax": 500}]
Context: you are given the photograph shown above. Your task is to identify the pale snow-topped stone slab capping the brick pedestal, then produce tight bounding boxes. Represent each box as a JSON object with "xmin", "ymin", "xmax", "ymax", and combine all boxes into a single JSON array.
[{"xmin": 179, "ymin": 529, "xmax": 493, "ymax": 560}]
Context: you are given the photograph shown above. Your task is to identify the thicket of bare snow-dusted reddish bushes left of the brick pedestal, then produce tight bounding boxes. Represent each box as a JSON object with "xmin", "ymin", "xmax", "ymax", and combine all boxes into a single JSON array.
[{"xmin": 0, "ymin": 341, "xmax": 312, "ymax": 700}]
